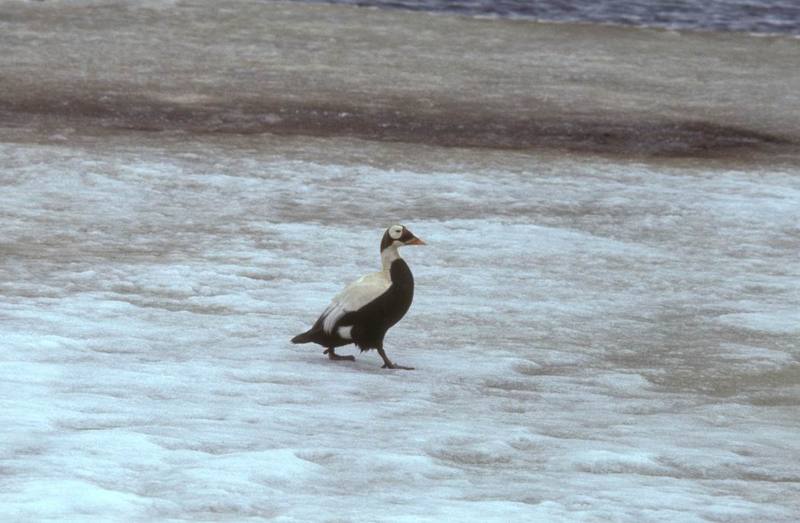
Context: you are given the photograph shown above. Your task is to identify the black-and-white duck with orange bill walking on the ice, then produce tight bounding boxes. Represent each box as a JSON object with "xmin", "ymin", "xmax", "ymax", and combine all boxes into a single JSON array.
[{"xmin": 292, "ymin": 225, "xmax": 426, "ymax": 370}]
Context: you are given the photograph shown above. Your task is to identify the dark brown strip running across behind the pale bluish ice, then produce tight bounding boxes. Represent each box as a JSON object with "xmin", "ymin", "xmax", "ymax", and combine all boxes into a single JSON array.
[{"xmin": 0, "ymin": 89, "xmax": 800, "ymax": 158}]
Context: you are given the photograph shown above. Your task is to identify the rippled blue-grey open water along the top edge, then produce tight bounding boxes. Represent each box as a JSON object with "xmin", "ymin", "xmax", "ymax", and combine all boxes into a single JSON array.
[{"xmin": 298, "ymin": 0, "xmax": 800, "ymax": 35}]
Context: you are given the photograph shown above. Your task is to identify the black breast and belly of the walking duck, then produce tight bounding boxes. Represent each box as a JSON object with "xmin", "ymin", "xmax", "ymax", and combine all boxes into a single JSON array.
[{"xmin": 340, "ymin": 258, "xmax": 414, "ymax": 350}]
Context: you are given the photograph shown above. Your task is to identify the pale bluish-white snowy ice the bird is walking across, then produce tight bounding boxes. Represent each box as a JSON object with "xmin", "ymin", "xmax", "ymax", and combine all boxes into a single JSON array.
[{"xmin": 0, "ymin": 133, "xmax": 800, "ymax": 522}]
